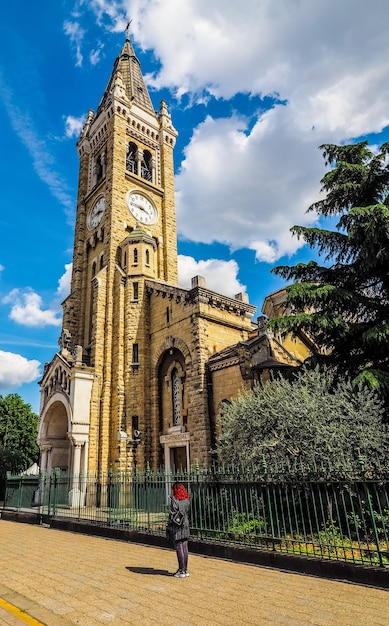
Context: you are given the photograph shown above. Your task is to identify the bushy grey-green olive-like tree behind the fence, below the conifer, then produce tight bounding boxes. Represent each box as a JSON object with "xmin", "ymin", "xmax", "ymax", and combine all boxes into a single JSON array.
[{"xmin": 216, "ymin": 367, "xmax": 389, "ymax": 468}]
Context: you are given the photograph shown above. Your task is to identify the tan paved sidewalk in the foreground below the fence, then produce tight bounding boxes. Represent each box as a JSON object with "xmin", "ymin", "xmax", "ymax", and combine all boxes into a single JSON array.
[{"xmin": 0, "ymin": 520, "xmax": 389, "ymax": 626}]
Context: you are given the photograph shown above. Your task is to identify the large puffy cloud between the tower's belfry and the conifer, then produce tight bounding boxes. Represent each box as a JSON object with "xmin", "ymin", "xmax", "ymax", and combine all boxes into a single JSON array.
[{"xmin": 176, "ymin": 106, "xmax": 322, "ymax": 263}]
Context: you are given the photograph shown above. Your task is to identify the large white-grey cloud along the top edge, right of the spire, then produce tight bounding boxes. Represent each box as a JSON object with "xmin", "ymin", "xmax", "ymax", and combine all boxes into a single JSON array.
[{"xmin": 126, "ymin": 0, "xmax": 388, "ymax": 112}]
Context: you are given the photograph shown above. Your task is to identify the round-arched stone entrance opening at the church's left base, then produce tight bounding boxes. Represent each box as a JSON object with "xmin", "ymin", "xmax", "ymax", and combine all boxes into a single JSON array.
[{"xmin": 38, "ymin": 397, "xmax": 71, "ymax": 473}]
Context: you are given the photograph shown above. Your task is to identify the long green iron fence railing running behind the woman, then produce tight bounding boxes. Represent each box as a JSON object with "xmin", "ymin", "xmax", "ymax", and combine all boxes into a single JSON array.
[{"xmin": 4, "ymin": 465, "xmax": 389, "ymax": 567}]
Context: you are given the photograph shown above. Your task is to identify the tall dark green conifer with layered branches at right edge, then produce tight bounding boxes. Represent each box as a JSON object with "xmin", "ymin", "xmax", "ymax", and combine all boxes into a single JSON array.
[{"xmin": 269, "ymin": 141, "xmax": 389, "ymax": 392}]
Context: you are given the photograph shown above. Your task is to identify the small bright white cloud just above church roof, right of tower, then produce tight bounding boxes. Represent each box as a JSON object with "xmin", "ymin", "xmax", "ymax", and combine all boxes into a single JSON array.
[{"xmin": 178, "ymin": 254, "xmax": 246, "ymax": 297}]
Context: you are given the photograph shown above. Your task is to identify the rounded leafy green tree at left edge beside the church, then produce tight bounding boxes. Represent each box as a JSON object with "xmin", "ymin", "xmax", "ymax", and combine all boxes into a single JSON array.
[{"xmin": 0, "ymin": 393, "xmax": 39, "ymax": 476}]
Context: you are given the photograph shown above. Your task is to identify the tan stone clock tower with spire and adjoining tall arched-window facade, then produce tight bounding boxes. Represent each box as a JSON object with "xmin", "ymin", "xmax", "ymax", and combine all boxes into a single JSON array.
[{"xmin": 38, "ymin": 35, "xmax": 255, "ymax": 491}]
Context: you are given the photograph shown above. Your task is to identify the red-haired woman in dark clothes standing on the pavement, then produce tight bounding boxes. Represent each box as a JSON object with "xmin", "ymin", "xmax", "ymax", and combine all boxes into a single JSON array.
[{"xmin": 166, "ymin": 483, "xmax": 190, "ymax": 578}]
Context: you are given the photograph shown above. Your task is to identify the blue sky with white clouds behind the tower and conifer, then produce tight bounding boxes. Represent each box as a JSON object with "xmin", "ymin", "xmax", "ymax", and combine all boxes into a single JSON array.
[{"xmin": 0, "ymin": 0, "xmax": 389, "ymax": 412}]
